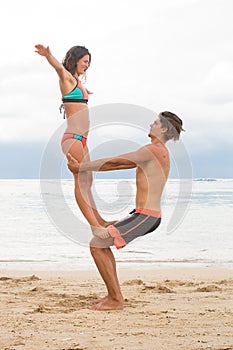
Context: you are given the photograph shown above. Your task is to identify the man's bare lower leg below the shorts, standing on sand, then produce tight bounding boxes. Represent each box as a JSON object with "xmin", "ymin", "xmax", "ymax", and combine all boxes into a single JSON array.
[{"xmin": 90, "ymin": 239, "xmax": 123, "ymax": 310}]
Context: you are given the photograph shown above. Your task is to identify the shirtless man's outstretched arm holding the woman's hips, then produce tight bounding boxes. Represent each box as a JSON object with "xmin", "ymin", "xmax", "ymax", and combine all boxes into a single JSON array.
[{"xmin": 67, "ymin": 146, "xmax": 153, "ymax": 173}]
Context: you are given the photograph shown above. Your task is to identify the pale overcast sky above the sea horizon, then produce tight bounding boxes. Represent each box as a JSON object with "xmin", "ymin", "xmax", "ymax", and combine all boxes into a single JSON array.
[{"xmin": 0, "ymin": 0, "xmax": 233, "ymax": 178}]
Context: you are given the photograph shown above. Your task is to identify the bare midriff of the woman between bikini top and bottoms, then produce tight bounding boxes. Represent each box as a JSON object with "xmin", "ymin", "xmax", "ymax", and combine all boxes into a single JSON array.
[{"xmin": 64, "ymin": 103, "xmax": 90, "ymax": 137}]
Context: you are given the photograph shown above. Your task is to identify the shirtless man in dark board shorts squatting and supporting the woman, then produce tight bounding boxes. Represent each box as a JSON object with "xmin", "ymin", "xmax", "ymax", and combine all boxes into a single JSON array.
[{"xmin": 67, "ymin": 112, "xmax": 184, "ymax": 310}]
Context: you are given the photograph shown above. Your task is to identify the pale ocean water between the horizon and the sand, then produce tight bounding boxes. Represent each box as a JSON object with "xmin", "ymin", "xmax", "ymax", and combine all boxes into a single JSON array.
[{"xmin": 0, "ymin": 179, "xmax": 233, "ymax": 271}]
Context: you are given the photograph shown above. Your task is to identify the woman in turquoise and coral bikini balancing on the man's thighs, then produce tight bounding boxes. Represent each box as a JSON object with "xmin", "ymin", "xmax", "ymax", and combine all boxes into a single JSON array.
[{"xmin": 35, "ymin": 44, "xmax": 109, "ymax": 226}]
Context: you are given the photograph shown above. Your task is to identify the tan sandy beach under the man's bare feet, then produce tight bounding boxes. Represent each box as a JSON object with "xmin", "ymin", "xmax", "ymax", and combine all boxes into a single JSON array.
[{"xmin": 0, "ymin": 267, "xmax": 233, "ymax": 350}]
